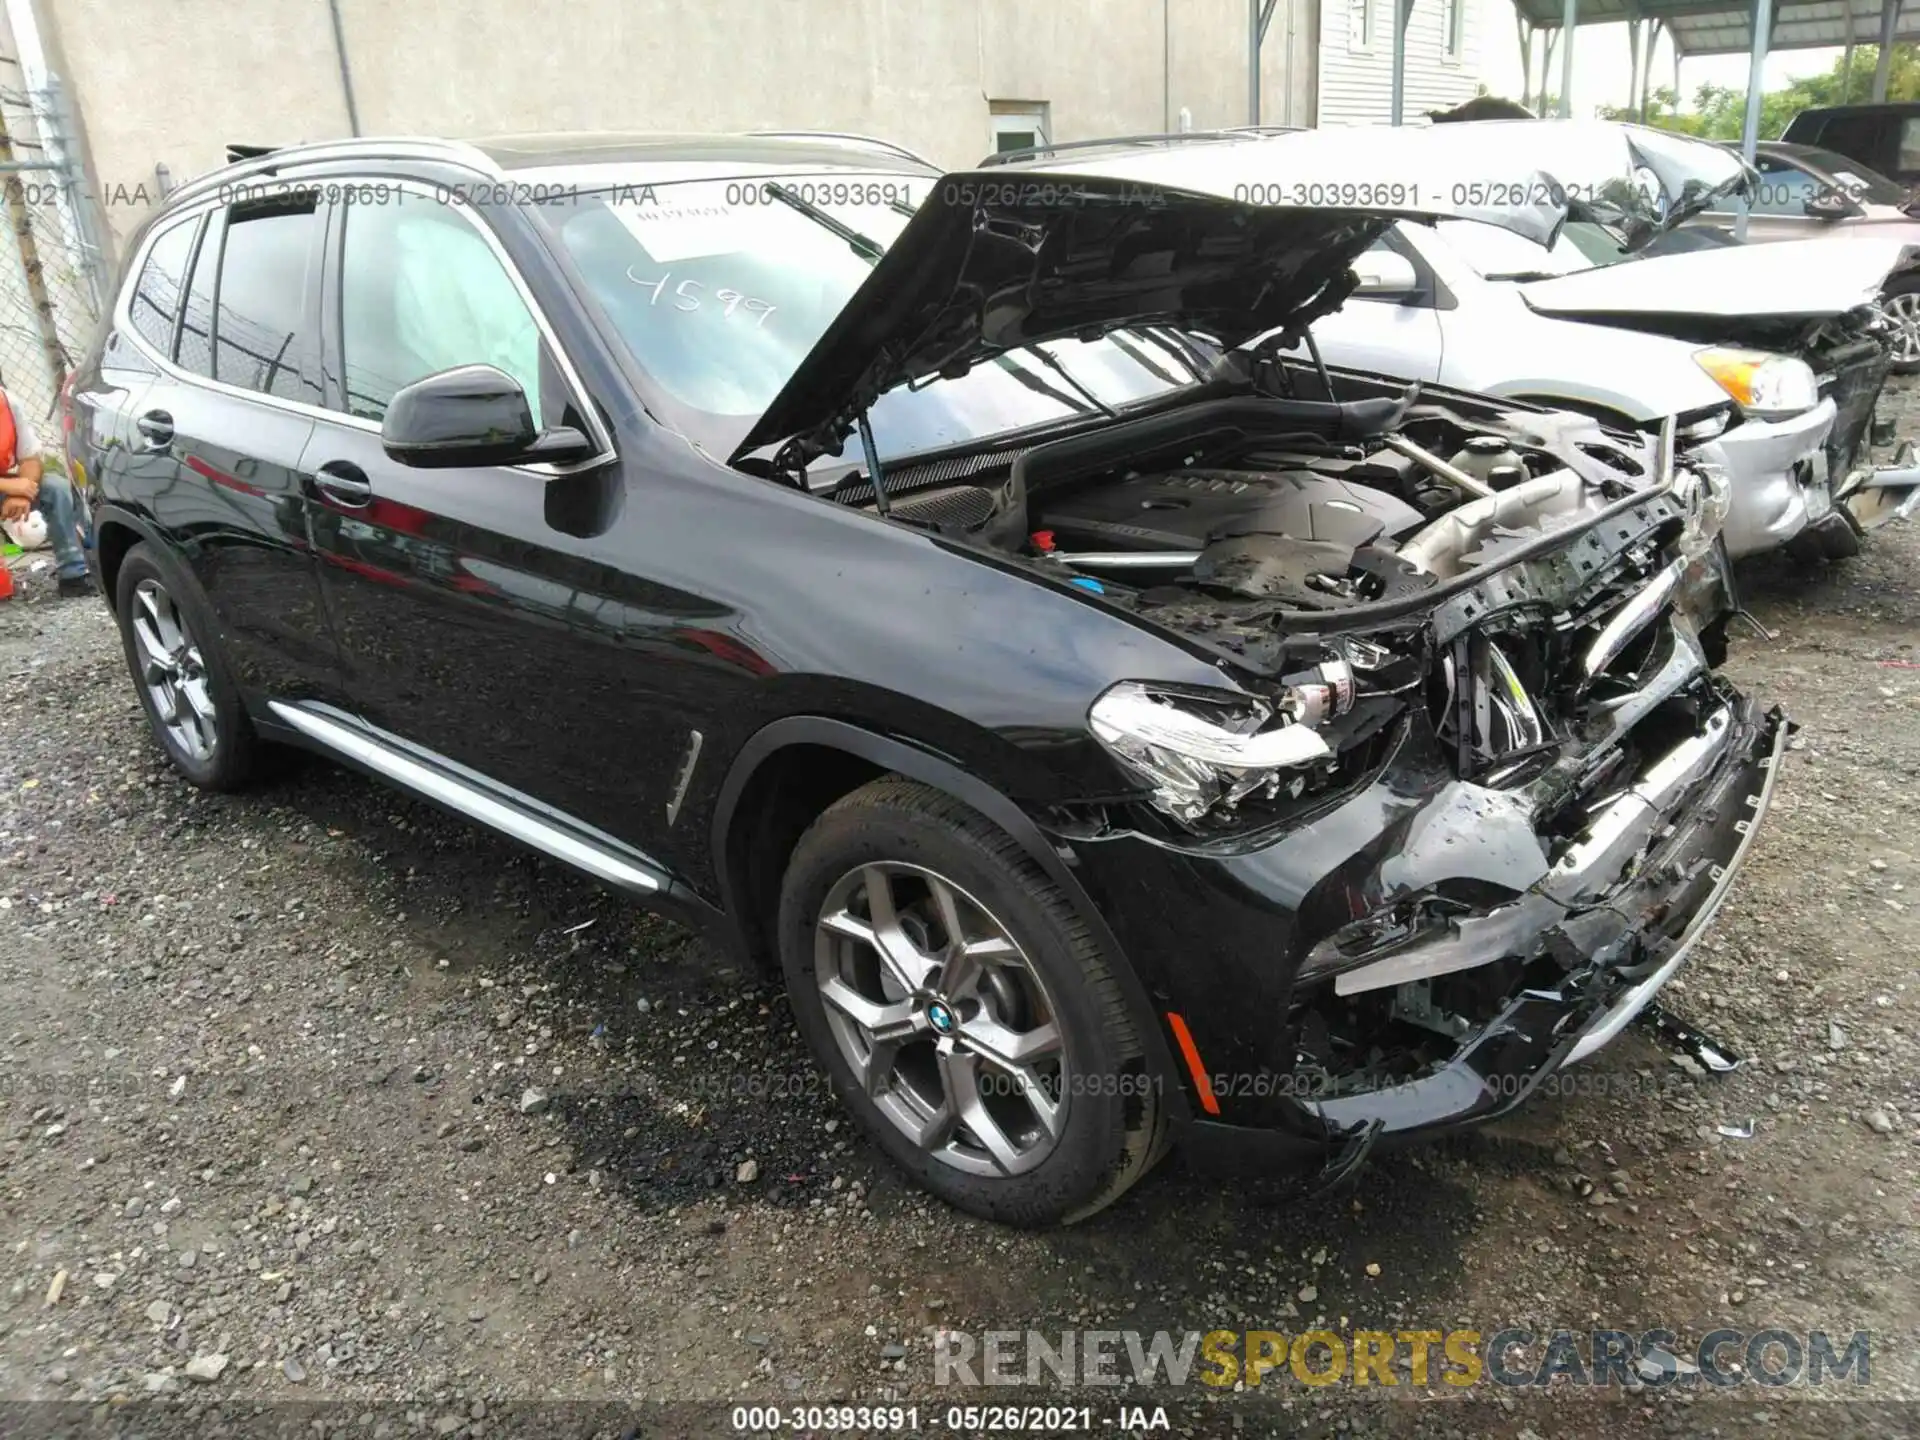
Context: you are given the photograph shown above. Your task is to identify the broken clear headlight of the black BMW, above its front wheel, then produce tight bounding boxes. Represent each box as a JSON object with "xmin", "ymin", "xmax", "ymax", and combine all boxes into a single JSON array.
[{"xmin": 1087, "ymin": 660, "xmax": 1354, "ymax": 828}]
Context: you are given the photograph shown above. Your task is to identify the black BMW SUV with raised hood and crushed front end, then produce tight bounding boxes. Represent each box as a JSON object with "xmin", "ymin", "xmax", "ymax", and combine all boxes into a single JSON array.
[{"xmin": 69, "ymin": 127, "xmax": 1784, "ymax": 1223}]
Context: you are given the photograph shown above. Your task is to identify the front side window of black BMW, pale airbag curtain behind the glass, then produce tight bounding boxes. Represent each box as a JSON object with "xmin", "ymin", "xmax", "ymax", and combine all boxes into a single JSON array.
[{"xmin": 340, "ymin": 190, "xmax": 541, "ymax": 428}]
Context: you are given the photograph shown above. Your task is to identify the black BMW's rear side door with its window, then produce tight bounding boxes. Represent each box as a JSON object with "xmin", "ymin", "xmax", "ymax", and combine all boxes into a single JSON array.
[{"xmin": 102, "ymin": 196, "xmax": 338, "ymax": 695}]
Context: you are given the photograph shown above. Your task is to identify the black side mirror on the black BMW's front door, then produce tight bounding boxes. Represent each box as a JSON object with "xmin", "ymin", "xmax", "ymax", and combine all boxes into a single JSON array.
[{"xmin": 380, "ymin": 365, "xmax": 593, "ymax": 470}]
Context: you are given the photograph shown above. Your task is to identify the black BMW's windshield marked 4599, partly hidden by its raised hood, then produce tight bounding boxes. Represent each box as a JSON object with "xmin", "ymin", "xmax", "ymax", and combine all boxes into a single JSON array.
[{"xmin": 545, "ymin": 171, "xmax": 1198, "ymax": 455}]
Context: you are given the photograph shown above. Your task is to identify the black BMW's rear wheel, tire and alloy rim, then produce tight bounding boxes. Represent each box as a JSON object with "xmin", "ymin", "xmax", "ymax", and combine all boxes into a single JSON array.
[{"xmin": 113, "ymin": 543, "xmax": 263, "ymax": 791}]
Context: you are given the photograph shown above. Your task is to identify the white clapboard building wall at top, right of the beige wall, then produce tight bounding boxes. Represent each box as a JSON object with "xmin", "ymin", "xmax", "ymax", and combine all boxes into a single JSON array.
[{"xmin": 1317, "ymin": 0, "xmax": 1486, "ymax": 125}]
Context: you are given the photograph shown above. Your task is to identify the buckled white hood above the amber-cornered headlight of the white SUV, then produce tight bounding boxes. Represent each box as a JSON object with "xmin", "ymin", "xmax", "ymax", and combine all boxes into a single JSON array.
[{"xmin": 1521, "ymin": 240, "xmax": 1910, "ymax": 323}]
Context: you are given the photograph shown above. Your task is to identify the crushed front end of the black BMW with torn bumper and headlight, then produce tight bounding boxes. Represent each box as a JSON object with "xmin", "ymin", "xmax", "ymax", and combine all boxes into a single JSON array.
[{"xmin": 1033, "ymin": 380, "xmax": 1789, "ymax": 1167}]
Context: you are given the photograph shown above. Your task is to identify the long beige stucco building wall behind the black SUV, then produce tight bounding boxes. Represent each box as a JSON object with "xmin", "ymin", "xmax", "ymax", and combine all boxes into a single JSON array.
[{"xmin": 33, "ymin": 0, "xmax": 1317, "ymax": 253}]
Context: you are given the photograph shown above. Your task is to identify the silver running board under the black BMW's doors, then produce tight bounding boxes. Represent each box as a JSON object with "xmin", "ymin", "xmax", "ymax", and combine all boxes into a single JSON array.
[{"xmin": 267, "ymin": 701, "xmax": 668, "ymax": 895}]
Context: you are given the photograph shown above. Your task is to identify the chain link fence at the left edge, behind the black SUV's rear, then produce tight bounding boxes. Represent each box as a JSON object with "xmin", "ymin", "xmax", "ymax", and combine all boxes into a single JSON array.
[{"xmin": 0, "ymin": 56, "xmax": 108, "ymax": 453}]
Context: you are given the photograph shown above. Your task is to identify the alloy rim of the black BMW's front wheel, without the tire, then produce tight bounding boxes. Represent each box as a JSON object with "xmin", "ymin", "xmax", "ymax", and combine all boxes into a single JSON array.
[{"xmin": 814, "ymin": 862, "xmax": 1069, "ymax": 1175}]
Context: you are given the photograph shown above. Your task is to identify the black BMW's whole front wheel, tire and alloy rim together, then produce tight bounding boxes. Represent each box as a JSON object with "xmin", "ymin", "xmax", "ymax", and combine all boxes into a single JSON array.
[{"xmin": 780, "ymin": 776, "xmax": 1167, "ymax": 1227}]
